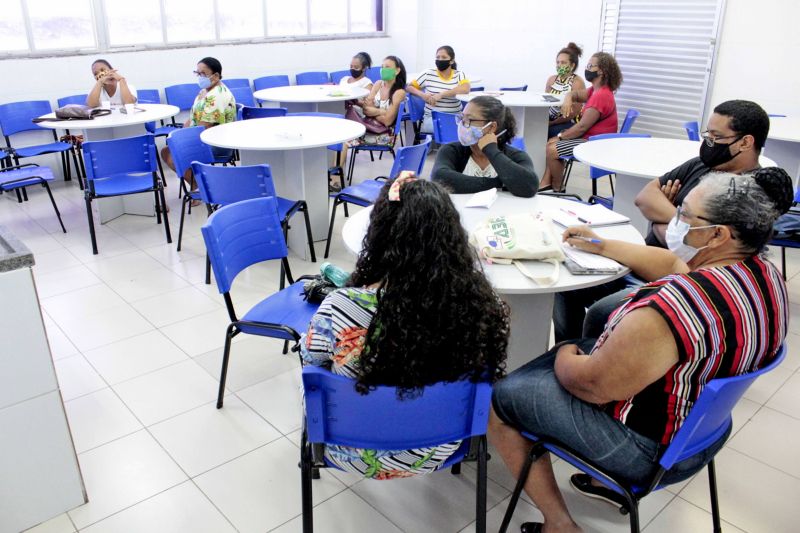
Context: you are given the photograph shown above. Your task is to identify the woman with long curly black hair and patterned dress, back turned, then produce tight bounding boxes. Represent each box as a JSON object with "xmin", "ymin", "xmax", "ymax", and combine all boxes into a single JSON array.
[{"xmin": 300, "ymin": 173, "xmax": 509, "ymax": 479}]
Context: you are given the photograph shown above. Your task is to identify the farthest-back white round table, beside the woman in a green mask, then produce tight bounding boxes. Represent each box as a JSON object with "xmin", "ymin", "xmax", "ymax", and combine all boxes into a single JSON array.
[{"xmin": 253, "ymin": 85, "xmax": 369, "ymax": 114}]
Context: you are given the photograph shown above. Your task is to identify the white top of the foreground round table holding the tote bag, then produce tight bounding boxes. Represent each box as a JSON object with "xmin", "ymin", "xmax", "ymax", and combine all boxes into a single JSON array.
[{"xmin": 342, "ymin": 192, "xmax": 644, "ymax": 294}]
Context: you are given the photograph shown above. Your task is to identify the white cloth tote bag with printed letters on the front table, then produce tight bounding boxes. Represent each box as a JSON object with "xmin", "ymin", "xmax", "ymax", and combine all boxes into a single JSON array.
[{"xmin": 469, "ymin": 213, "xmax": 564, "ymax": 287}]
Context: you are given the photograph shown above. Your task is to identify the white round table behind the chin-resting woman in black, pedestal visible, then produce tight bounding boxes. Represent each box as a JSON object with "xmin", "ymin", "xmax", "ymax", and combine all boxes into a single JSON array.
[{"xmin": 456, "ymin": 91, "xmax": 562, "ymax": 177}]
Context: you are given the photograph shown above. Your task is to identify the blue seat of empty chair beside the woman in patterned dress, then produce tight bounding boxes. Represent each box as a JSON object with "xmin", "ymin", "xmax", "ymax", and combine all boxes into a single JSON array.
[{"xmin": 239, "ymin": 281, "xmax": 319, "ymax": 340}]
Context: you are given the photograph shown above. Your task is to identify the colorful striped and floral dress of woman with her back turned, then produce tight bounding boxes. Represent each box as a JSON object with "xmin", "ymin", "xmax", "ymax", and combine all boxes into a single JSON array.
[{"xmin": 300, "ymin": 287, "xmax": 461, "ymax": 479}]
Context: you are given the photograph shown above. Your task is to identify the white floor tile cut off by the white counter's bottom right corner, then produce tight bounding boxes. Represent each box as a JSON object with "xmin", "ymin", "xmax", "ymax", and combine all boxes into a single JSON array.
[{"xmin": 69, "ymin": 431, "xmax": 187, "ymax": 529}]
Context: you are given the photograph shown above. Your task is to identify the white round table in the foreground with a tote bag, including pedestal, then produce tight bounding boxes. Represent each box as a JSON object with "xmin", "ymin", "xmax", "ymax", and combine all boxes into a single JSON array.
[{"xmin": 342, "ymin": 192, "xmax": 644, "ymax": 371}]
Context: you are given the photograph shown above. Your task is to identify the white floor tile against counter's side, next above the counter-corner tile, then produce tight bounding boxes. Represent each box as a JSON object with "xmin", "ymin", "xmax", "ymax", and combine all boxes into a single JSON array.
[{"xmin": 64, "ymin": 389, "xmax": 142, "ymax": 453}]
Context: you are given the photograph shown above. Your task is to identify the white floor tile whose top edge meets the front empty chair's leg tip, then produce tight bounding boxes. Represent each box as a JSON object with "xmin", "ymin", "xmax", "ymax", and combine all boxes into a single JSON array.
[{"xmin": 150, "ymin": 396, "xmax": 281, "ymax": 477}]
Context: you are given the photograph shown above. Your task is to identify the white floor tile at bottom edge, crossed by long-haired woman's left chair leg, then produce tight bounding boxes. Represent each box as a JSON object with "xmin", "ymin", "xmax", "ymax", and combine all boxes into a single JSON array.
[{"xmin": 194, "ymin": 438, "xmax": 345, "ymax": 533}]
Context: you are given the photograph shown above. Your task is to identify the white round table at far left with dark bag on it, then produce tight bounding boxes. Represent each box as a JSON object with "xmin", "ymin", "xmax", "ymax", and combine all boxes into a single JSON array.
[{"xmin": 38, "ymin": 104, "xmax": 180, "ymax": 224}]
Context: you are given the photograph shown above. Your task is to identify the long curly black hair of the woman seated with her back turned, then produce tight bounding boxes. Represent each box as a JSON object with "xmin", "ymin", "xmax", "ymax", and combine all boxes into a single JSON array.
[{"xmin": 348, "ymin": 179, "xmax": 509, "ymax": 397}]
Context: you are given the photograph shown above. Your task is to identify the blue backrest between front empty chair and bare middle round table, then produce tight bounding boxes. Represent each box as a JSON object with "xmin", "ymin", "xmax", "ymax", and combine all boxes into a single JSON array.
[{"xmin": 192, "ymin": 161, "xmax": 277, "ymax": 205}]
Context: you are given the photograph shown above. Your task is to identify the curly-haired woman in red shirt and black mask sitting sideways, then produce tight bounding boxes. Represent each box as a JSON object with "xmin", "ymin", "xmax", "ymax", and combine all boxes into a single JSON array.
[{"xmin": 539, "ymin": 52, "xmax": 622, "ymax": 191}]
